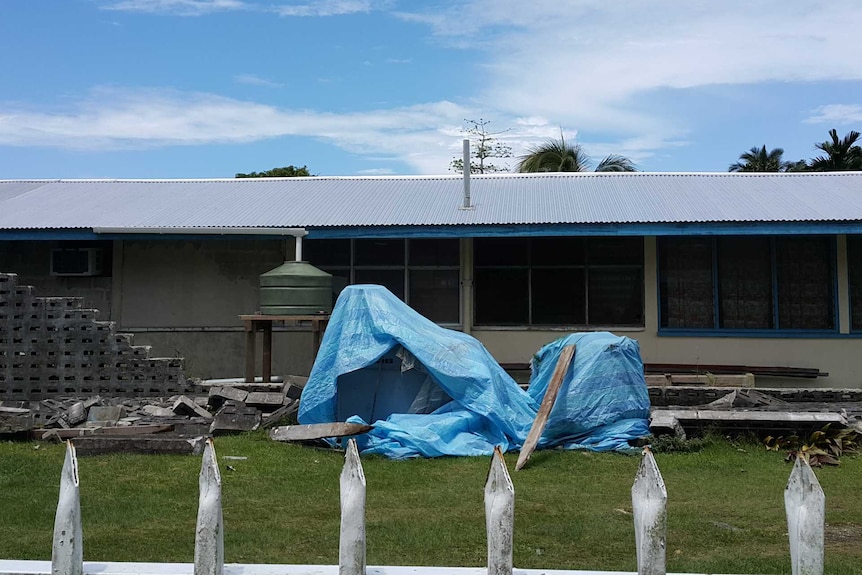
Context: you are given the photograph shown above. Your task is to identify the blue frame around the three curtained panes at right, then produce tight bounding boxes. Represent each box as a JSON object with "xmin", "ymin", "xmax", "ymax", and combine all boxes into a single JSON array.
[{"xmin": 655, "ymin": 234, "xmax": 836, "ymax": 338}]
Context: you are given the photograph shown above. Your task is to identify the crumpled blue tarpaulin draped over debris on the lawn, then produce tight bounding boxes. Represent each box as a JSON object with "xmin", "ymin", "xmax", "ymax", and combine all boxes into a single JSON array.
[{"xmin": 298, "ymin": 285, "xmax": 649, "ymax": 459}]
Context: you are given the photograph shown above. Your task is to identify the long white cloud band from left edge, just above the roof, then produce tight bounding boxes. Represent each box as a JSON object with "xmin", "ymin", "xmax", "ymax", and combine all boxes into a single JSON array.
[{"xmin": 0, "ymin": 88, "xmax": 472, "ymax": 173}]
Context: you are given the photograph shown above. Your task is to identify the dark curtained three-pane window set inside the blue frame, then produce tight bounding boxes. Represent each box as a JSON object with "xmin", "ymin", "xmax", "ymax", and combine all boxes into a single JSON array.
[{"xmin": 659, "ymin": 236, "xmax": 836, "ymax": 330}]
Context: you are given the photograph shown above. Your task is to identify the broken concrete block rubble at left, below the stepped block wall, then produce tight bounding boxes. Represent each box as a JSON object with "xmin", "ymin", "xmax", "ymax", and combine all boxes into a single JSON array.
[{"xmin": 0, "ymin": 376, "xmax": 306, "ymax": 455}]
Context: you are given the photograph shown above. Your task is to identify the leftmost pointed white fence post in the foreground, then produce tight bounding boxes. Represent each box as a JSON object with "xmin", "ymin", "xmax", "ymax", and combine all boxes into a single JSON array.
[{"xmin": 51, "ymin": 441, "xmax": 84, "ymax": 575}]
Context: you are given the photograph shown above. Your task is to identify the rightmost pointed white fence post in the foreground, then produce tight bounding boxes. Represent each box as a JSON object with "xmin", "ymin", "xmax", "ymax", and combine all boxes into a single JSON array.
[{"xmin": 784, "ymin": 457, "xmax": 826, "ymax": 575}]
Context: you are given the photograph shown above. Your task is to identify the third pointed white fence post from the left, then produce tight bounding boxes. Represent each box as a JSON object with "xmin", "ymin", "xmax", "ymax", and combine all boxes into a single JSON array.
[{"xmin": 338, "ymin": 439, "xmax": 365, "ymax": 575}]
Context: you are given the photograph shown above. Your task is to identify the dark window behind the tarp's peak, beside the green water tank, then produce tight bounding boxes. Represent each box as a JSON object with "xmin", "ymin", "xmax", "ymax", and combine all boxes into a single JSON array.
[{"xmin": 303, "ymin": 238, "xmax": 461, "ymax": 324}]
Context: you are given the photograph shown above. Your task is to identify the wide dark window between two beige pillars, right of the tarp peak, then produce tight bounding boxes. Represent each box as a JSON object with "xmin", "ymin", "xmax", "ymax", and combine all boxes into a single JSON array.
[{"xmin": 474, "ymin": 237, "xmax": 643, "ymax": 326}]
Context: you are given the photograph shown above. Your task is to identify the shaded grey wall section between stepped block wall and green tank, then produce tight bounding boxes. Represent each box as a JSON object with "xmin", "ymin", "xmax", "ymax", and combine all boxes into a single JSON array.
[{"xmin": 114, "ymin": 239, "xmax": 313, "ymax": 378}]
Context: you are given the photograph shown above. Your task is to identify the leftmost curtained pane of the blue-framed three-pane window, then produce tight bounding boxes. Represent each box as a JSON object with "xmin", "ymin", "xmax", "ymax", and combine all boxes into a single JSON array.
[{"xmin": 659, "ymin": 238, "xmax": 715, "ymax": 329}]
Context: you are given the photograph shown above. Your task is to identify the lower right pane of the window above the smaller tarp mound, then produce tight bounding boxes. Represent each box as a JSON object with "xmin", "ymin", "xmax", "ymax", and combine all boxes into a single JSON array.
[{"xmin": 589, "ymin": 267, "xmax": 643, "ymax": 326}]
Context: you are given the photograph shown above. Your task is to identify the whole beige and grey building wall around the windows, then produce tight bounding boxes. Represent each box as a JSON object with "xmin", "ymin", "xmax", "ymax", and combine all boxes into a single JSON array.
[{"xmin": 6, "ymin": 237, "xmax": 862, "ymax": 388}]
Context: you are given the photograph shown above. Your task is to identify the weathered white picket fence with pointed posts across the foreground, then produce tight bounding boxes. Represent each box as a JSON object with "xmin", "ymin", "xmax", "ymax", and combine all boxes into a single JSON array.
[{"xmin": 0, "ymin": 439, "xmax": 825, "ymax": 575}]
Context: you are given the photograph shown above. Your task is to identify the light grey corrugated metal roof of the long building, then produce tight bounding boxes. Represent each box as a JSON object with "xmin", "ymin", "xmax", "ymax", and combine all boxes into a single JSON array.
[{"xmin": 0, "ymin": 172, "xmax": 862, "ymax": 230}]
